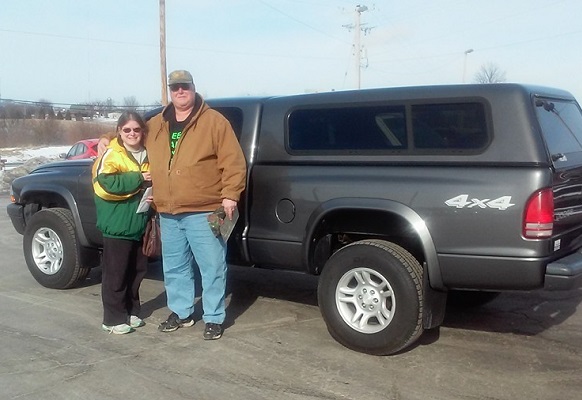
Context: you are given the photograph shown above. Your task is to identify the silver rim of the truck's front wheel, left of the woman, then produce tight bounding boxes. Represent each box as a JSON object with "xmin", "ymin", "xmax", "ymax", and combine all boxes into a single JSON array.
[{"xmin": 32, "ymin": 228, "xmax": 63, "ymax": 275}]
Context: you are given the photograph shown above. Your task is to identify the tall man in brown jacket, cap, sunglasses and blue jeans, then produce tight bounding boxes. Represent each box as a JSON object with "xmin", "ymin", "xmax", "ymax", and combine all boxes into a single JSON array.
[{"xmin": 98, "ymin": 70, "xmax": 246, "ymax": 340}]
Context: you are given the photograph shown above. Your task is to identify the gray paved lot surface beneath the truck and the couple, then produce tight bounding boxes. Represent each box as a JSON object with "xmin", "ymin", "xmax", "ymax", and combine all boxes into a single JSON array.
[{"xmin": 0, "ymin": 195, "xmax": 582, "ymax": 400}]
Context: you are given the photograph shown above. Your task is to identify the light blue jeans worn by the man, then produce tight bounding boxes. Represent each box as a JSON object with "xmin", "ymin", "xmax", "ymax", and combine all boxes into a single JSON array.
[{"xmin": 160, "ymin": 212, "xmax": 226, "ymax": 324}]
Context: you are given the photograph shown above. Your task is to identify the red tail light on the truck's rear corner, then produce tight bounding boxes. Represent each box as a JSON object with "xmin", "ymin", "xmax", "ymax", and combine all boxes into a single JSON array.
[{"xmin": 523, "ymin": 189, "xmax": 554, "ymax": 239}]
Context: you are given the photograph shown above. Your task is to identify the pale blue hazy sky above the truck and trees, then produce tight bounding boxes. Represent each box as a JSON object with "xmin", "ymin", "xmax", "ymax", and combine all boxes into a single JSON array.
[{"xmin": 0, "ymin": 0, "xmax": 582, "ymax": 105}]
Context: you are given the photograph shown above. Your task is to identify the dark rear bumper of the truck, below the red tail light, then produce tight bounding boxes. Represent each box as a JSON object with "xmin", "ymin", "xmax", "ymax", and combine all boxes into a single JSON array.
[{"xmin": 544, "ymin": 249, "xmax": 582, "ymax": 290}]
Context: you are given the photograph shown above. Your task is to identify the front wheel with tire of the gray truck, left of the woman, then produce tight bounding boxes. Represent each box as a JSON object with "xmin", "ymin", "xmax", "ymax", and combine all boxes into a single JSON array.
[{"xmin": 23, "ymin": 208, "xmax": 89, "ymax": 289}]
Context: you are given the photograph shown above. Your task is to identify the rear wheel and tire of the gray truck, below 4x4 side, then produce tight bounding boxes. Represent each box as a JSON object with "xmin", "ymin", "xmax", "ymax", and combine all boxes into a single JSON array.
[{"xmin": 317, "ymin": 240, "xmax": 423, "ymax": 355}]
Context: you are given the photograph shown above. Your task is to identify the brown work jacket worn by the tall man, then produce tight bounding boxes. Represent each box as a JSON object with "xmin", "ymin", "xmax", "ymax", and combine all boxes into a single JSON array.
[{"xmin": 145, "ymin": 94, "xmax": 246, "ymax": 214}]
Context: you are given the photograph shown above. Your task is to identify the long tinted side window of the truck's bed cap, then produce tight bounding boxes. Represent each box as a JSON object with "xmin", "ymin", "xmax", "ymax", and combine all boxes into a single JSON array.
[{"xmin": 288, "ymin": 102, "xmax": 489, "ymax": 154}]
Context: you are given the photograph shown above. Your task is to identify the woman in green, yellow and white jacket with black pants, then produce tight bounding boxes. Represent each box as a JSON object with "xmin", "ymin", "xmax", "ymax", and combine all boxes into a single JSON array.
[{"xmin": 93, "ymin": 111, "xmax": 151, "ymax": 334}]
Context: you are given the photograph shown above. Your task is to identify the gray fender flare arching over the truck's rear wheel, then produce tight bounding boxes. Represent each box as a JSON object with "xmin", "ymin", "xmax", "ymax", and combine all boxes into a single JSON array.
[{"xmin": 303, "ymin": 197, "xmax": 445, "ymax": 289}]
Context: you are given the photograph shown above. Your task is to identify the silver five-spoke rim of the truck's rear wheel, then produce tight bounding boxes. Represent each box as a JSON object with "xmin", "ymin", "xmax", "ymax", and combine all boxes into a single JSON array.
[{"xmin": 335, "ymin": 267, "xmax": 396, "ymax": 334}]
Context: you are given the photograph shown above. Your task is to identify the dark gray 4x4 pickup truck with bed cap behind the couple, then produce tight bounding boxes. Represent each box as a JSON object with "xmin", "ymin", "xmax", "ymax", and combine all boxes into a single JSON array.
[{"xmin": 8, "ymin": 84, "xmax": 582, "ymax": 354}]
